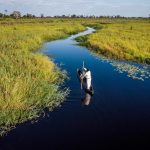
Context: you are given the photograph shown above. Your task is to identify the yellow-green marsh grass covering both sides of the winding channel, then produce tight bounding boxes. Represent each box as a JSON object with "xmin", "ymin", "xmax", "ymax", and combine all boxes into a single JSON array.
[{"xmin": 0, "ymin": 18, "xmax": 150, "ymax": 135}]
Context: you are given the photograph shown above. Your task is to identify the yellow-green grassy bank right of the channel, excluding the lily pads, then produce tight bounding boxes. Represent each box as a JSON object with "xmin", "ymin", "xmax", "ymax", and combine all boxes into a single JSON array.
[{"xmin": 77, "ymin": 19, "xmax": 150, "ymax": 64}]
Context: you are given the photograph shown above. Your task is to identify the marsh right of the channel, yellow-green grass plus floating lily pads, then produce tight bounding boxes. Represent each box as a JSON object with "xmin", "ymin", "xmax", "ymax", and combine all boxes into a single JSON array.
[{"xmin": 76, "ymin": 19, "xmax": 150, "ymax": 81}]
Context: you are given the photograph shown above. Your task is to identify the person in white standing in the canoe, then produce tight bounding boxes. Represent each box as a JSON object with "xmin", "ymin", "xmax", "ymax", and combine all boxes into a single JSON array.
[{"xmin": 81, "ymin": 68, "xmax": 92, "ymax": 90}]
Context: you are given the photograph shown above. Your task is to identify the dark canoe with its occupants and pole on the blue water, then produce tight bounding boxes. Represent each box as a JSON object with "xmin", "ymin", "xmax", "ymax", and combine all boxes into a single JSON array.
[{"xmin": 77, "ymin": 64, "xmax": 94, "ymax": 95}]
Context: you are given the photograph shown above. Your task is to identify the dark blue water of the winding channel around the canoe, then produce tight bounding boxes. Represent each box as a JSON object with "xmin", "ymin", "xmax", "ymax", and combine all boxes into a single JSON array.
[{"xmin": 0, "ymin": 28, "xmax": 150, "ymax": 150}]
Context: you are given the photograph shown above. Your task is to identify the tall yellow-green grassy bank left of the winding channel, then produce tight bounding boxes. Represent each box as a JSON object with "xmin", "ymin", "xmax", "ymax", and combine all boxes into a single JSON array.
[{"xmin": 0, "ymin": 19, "xmax": 85, "ymax": 135}]
